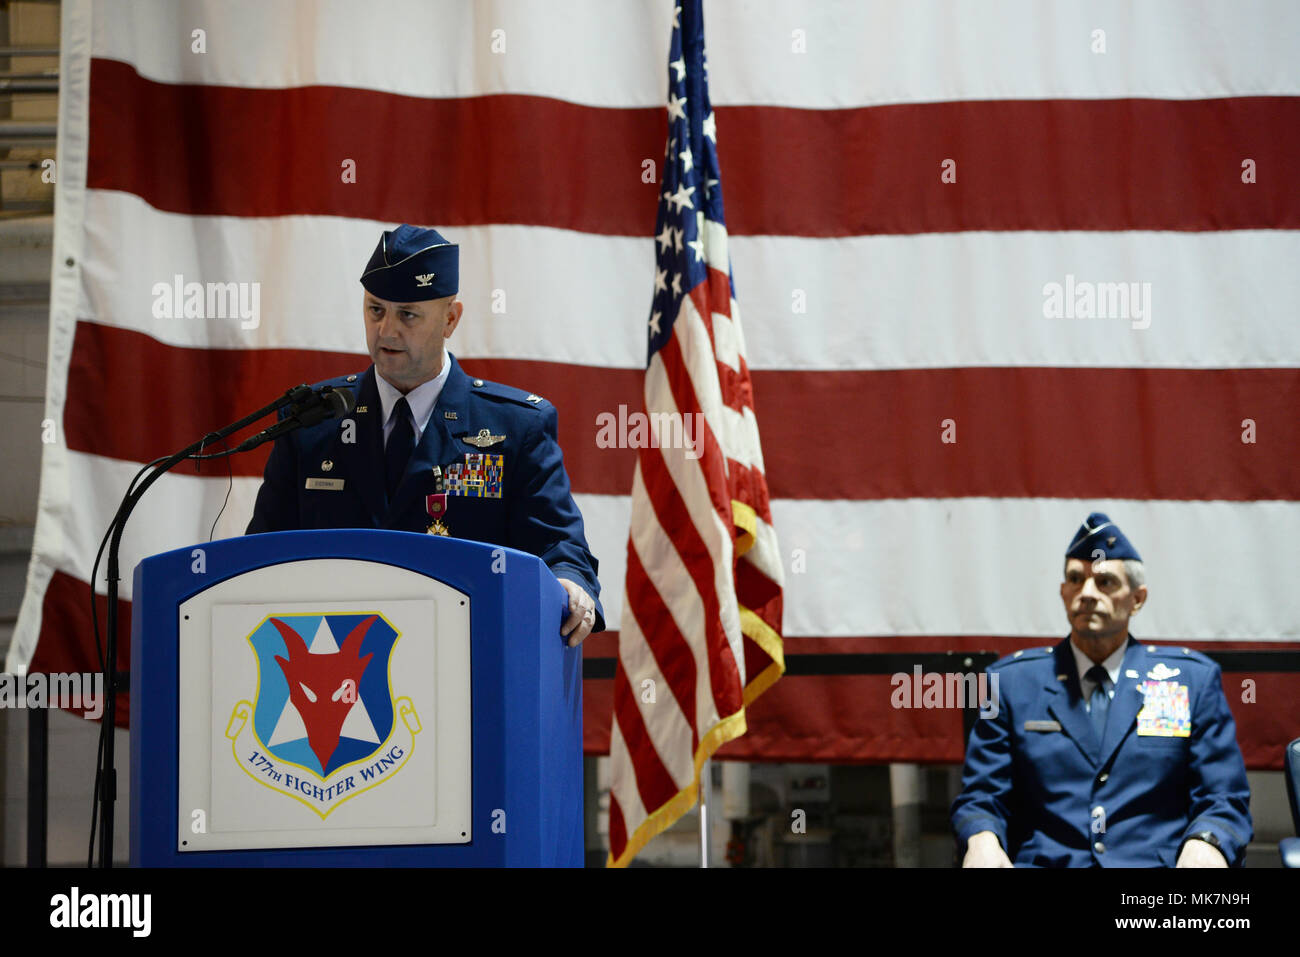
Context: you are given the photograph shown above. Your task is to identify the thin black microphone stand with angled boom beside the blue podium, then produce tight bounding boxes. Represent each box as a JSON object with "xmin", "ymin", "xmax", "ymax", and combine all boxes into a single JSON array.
[{"xmin": 91, "ymin": 385, "xmax": 312, "ymax": 867}]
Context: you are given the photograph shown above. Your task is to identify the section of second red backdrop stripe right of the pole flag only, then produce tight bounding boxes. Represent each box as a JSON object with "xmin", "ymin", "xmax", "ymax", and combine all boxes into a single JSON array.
[{"xmin": 754, "ymin": 368, "xmax": 1300, "ymax": 501}]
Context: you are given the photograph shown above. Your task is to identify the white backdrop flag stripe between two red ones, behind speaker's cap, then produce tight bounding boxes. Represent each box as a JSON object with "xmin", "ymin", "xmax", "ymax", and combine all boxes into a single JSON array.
[{"xmin": 78, "ymin": 190, "xmax": 1300, "ymax": 369}]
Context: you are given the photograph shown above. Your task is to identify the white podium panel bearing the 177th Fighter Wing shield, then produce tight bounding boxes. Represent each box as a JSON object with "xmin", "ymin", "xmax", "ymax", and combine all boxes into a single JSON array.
[{"xmin": 177, "ymin": 559, "xmax": 472, "ymax": 852}]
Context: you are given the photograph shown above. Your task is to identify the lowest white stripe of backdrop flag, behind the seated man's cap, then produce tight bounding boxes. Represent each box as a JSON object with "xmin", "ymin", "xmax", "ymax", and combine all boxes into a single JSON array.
[{"xmin": 20, "ymin": 451, "xmax": 1300, "ymax": 641}]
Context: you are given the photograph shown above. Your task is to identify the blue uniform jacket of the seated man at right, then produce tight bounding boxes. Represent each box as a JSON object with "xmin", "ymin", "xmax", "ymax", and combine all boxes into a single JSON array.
[{"xmin": 952, "ymin": 637, "xmax": 1253, "ymax": 867}]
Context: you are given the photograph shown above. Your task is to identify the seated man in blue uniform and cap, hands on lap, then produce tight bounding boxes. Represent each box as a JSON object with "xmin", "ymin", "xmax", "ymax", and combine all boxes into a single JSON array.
[{"xmin": 952, "ymin": 512, "xmax": 1253, "ymax": 867}]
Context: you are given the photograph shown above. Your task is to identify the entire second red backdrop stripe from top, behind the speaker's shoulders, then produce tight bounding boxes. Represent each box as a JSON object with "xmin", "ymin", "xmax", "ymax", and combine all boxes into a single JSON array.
[{"xmin": 64, "ymin": 322, "xmax": 1300, "ymax": 502}]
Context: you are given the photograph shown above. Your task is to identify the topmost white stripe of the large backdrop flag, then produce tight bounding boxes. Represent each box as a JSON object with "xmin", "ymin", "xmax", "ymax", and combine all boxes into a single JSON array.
[{"xmin": 94, "ymin": 0, "xmax": 1300, "ymax": 109}]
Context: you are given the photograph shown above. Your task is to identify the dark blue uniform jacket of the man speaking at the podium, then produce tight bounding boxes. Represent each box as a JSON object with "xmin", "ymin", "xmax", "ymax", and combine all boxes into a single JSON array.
[{"xmin": 247, "ymin": 354, "xmax": 605, "ymax": 631}]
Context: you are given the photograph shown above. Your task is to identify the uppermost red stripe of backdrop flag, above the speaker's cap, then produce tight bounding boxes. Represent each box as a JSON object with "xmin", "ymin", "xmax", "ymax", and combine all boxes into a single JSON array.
[{"xmin": 87, "ymin": 59, "xmax": 1300, "ymax": 237}]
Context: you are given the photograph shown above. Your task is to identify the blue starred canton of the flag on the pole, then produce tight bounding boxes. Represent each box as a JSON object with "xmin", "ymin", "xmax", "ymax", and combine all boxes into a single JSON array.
[{"xmin": 646, "ymin": 0, "xmax": 735, "ymax": 363}]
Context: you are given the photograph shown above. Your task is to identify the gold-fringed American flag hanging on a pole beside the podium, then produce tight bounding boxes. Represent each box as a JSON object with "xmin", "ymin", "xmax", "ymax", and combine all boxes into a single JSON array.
[{"xmin": 610, "ymin": 0, "xmax": 785, "ymax": 866}]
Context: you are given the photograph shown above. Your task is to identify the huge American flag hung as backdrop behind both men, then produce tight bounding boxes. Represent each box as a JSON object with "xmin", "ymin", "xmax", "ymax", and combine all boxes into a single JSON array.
[{"xmin": 7, "ymin": 0, "xmax": 1300, "ymax": 790}]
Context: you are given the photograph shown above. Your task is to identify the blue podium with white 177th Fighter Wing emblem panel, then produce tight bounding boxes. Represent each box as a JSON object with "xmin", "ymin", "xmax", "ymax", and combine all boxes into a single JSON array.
[{"xmin": 130, "ymin": 529, "xmax": 584, "ymax": 867}]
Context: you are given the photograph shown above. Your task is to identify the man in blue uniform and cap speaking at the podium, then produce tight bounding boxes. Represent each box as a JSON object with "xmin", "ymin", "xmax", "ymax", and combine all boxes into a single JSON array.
[{"xmin": 247, "ymin": 225, "xmax": 605, "ymax": 645}]
